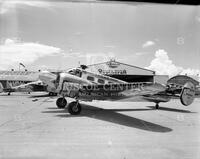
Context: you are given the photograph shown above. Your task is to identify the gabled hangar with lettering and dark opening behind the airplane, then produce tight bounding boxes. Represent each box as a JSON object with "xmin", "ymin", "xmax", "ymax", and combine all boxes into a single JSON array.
[{"xmin": 86, "ymin": 59, "xmax": 162, "ymax": 82}]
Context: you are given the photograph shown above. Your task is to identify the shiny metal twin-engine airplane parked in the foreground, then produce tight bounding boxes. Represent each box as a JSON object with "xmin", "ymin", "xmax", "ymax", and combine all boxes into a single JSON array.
[{"xmin": 39, "ymin": 68, "xmax": 196, "ymax": 115}]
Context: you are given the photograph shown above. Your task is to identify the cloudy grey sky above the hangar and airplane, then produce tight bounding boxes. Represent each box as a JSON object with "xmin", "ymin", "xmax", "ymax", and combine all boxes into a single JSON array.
[{"xmin": 0, "ymin": 0, "xmax": 200, "ymax": 76}]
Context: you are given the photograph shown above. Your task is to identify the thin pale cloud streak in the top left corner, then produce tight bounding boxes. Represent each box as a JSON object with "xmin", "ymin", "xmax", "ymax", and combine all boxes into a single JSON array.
[{"xmin": 0, "ymin": 0, "xmax": 51, "ymax": 14}]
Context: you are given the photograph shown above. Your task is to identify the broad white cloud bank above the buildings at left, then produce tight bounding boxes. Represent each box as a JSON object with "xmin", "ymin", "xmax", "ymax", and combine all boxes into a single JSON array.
[{"xmin": 0, "ymin": 39, "xmax": 62, "ymax": 69}]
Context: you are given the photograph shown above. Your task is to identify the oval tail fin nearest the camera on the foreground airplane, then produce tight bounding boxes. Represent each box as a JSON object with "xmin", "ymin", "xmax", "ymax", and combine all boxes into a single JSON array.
[{"xmin": 180, "ymin": 82, "xmax": 195, "ymax": 106}]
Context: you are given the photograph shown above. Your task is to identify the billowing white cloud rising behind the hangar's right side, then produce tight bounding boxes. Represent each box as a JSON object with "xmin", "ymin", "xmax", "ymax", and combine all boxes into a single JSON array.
[{"xmin": 146, "ymin": 50, "xmax": 200, "ymax": 80}]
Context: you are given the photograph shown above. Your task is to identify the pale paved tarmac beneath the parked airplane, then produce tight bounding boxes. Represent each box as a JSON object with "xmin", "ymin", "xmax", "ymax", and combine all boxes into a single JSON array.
[{"xmin": 0, "ymin": 93, "xmax": 200, "ymax": 159}]
